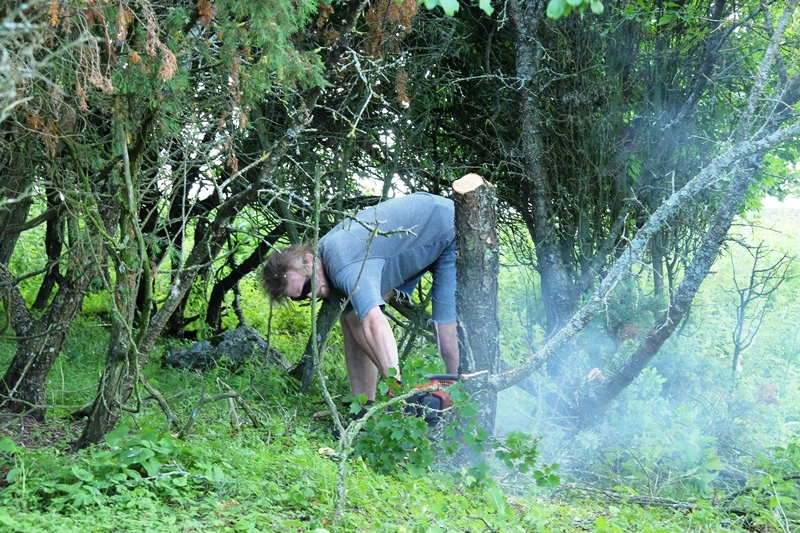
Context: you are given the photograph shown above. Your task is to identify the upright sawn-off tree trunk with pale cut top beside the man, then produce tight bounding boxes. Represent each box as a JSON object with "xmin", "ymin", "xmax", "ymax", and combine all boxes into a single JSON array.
[{"xmin": 453, "ymin": 174, "xmax": 500, "ymax": 435}]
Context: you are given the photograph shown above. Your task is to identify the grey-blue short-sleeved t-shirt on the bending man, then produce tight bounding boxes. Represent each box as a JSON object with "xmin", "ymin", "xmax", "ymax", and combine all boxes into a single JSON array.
[{"xmin": 319, "ymin": 193, "xmax": 455, "ymax": 321}]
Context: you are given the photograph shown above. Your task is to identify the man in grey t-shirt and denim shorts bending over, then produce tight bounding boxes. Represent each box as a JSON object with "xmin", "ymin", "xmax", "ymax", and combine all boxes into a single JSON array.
[{"xmin": 262, "ymin": 193, "xmax": 459, "ymax": 400}]
